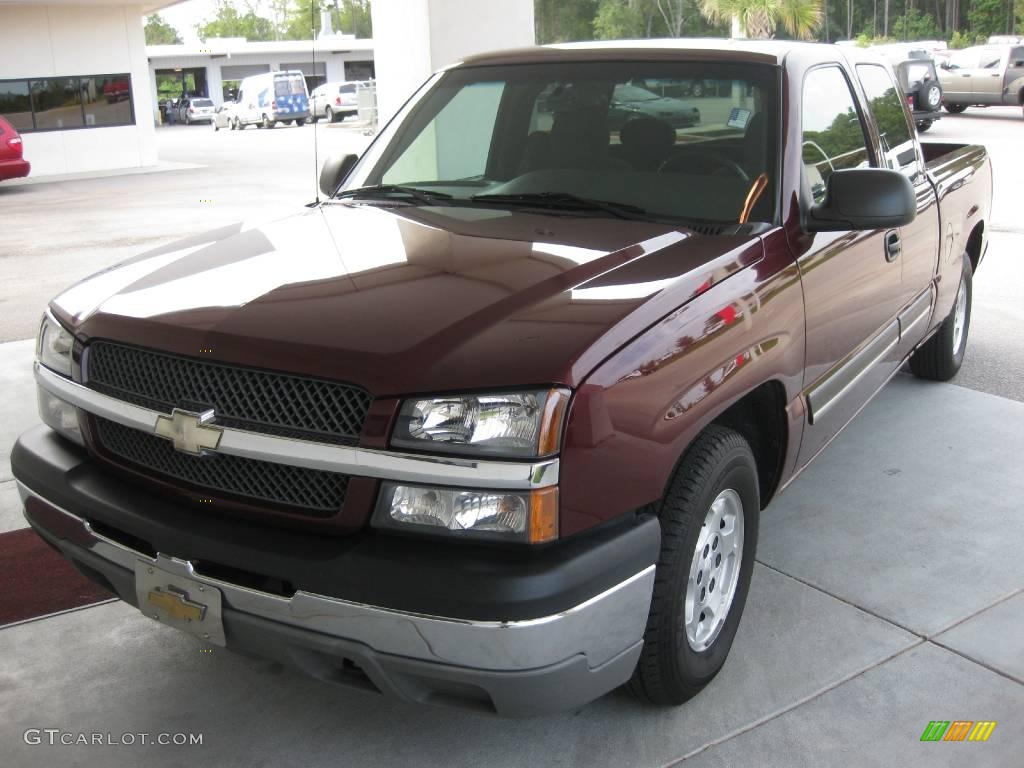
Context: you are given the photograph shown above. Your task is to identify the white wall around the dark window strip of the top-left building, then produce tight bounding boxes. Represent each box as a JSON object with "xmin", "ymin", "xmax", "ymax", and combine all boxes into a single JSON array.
[{"xmin": 0, "ymin": 4, "xmax": 157, "ymax": 176}]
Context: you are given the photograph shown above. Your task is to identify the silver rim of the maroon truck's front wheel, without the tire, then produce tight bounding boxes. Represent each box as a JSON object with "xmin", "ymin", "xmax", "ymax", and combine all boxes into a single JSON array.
[{"xmin": 683, "ymin": 488, "xmax": 743, "ymax": 653}]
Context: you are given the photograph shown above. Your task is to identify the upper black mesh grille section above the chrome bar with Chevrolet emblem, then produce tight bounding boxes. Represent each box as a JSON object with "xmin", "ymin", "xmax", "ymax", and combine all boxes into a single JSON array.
[{"xmin": 86, "ymin": 341, "xmax": 372, "ymax": 444}]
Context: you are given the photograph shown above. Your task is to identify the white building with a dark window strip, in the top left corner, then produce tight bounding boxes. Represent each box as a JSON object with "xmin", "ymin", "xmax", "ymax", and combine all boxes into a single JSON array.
[{"xmin": 0, "ymin": 0, "xmax": 173, "ymax": 176}]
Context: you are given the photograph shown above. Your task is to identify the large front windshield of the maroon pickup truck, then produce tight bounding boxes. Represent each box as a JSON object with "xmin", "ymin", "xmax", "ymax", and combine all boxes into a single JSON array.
[{"xmin": 345, "ymin": 61, "xmax": 778, "ymax": 223}]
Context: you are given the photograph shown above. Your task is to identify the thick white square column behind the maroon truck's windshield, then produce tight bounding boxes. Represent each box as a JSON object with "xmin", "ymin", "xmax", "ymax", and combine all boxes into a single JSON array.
[{"xmin": 370, "ymin": 0, "xmax": 536, "ymax": 125}]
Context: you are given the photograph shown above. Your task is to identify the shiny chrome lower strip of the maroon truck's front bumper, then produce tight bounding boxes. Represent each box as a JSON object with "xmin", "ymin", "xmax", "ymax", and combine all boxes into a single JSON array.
[{"xmin": 17, "ymin": 481, "xmax": 654, "ymax": 672}]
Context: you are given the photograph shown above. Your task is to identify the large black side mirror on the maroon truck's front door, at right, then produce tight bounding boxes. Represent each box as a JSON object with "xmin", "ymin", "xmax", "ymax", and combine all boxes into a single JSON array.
[{"xmin": 807, "ymin": 168, "xmax": 918, "ymax": 232}]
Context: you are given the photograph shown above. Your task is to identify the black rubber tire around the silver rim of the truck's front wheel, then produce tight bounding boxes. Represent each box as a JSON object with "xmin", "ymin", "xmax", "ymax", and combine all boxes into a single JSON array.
[{"xmin": 629, "ymin": 425, "xmax": 761, "ymax": 705}]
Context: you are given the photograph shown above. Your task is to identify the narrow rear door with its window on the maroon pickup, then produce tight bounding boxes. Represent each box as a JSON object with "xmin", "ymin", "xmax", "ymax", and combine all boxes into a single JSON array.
[{"xmin": 857, "ymin": 65, "xmax": 939, "ymax": 313}]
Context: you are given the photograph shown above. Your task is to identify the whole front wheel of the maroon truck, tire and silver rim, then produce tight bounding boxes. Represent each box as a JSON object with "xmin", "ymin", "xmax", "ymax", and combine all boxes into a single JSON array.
[{"xmin": 629, "ymin": 425, "xmax": 761, "ymax": 705}]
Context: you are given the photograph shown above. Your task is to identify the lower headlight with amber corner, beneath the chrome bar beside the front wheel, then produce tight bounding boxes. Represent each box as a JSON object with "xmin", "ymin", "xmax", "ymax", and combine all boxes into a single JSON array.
[{"xmin": 373, "ymin": 482, "xmax": 558, "ymax": 544}]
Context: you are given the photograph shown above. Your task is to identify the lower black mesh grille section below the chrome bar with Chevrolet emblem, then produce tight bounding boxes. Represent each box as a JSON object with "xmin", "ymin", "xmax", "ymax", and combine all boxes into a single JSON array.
[{"xmin": 94, "ymin": 417, "xmax": 348, "ymax": 517}]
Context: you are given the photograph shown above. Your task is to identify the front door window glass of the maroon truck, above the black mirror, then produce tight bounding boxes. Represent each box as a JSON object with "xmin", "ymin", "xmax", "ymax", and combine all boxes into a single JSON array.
[{"xmin": 802, "ymin": 67, "xmax": 870, "ymax": 203}]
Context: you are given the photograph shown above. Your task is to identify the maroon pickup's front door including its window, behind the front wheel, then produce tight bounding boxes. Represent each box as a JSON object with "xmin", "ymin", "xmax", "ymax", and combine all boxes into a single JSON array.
[{"xmin": 793, "ymin": 65, "xmax": 902, "ymax": 464}]
